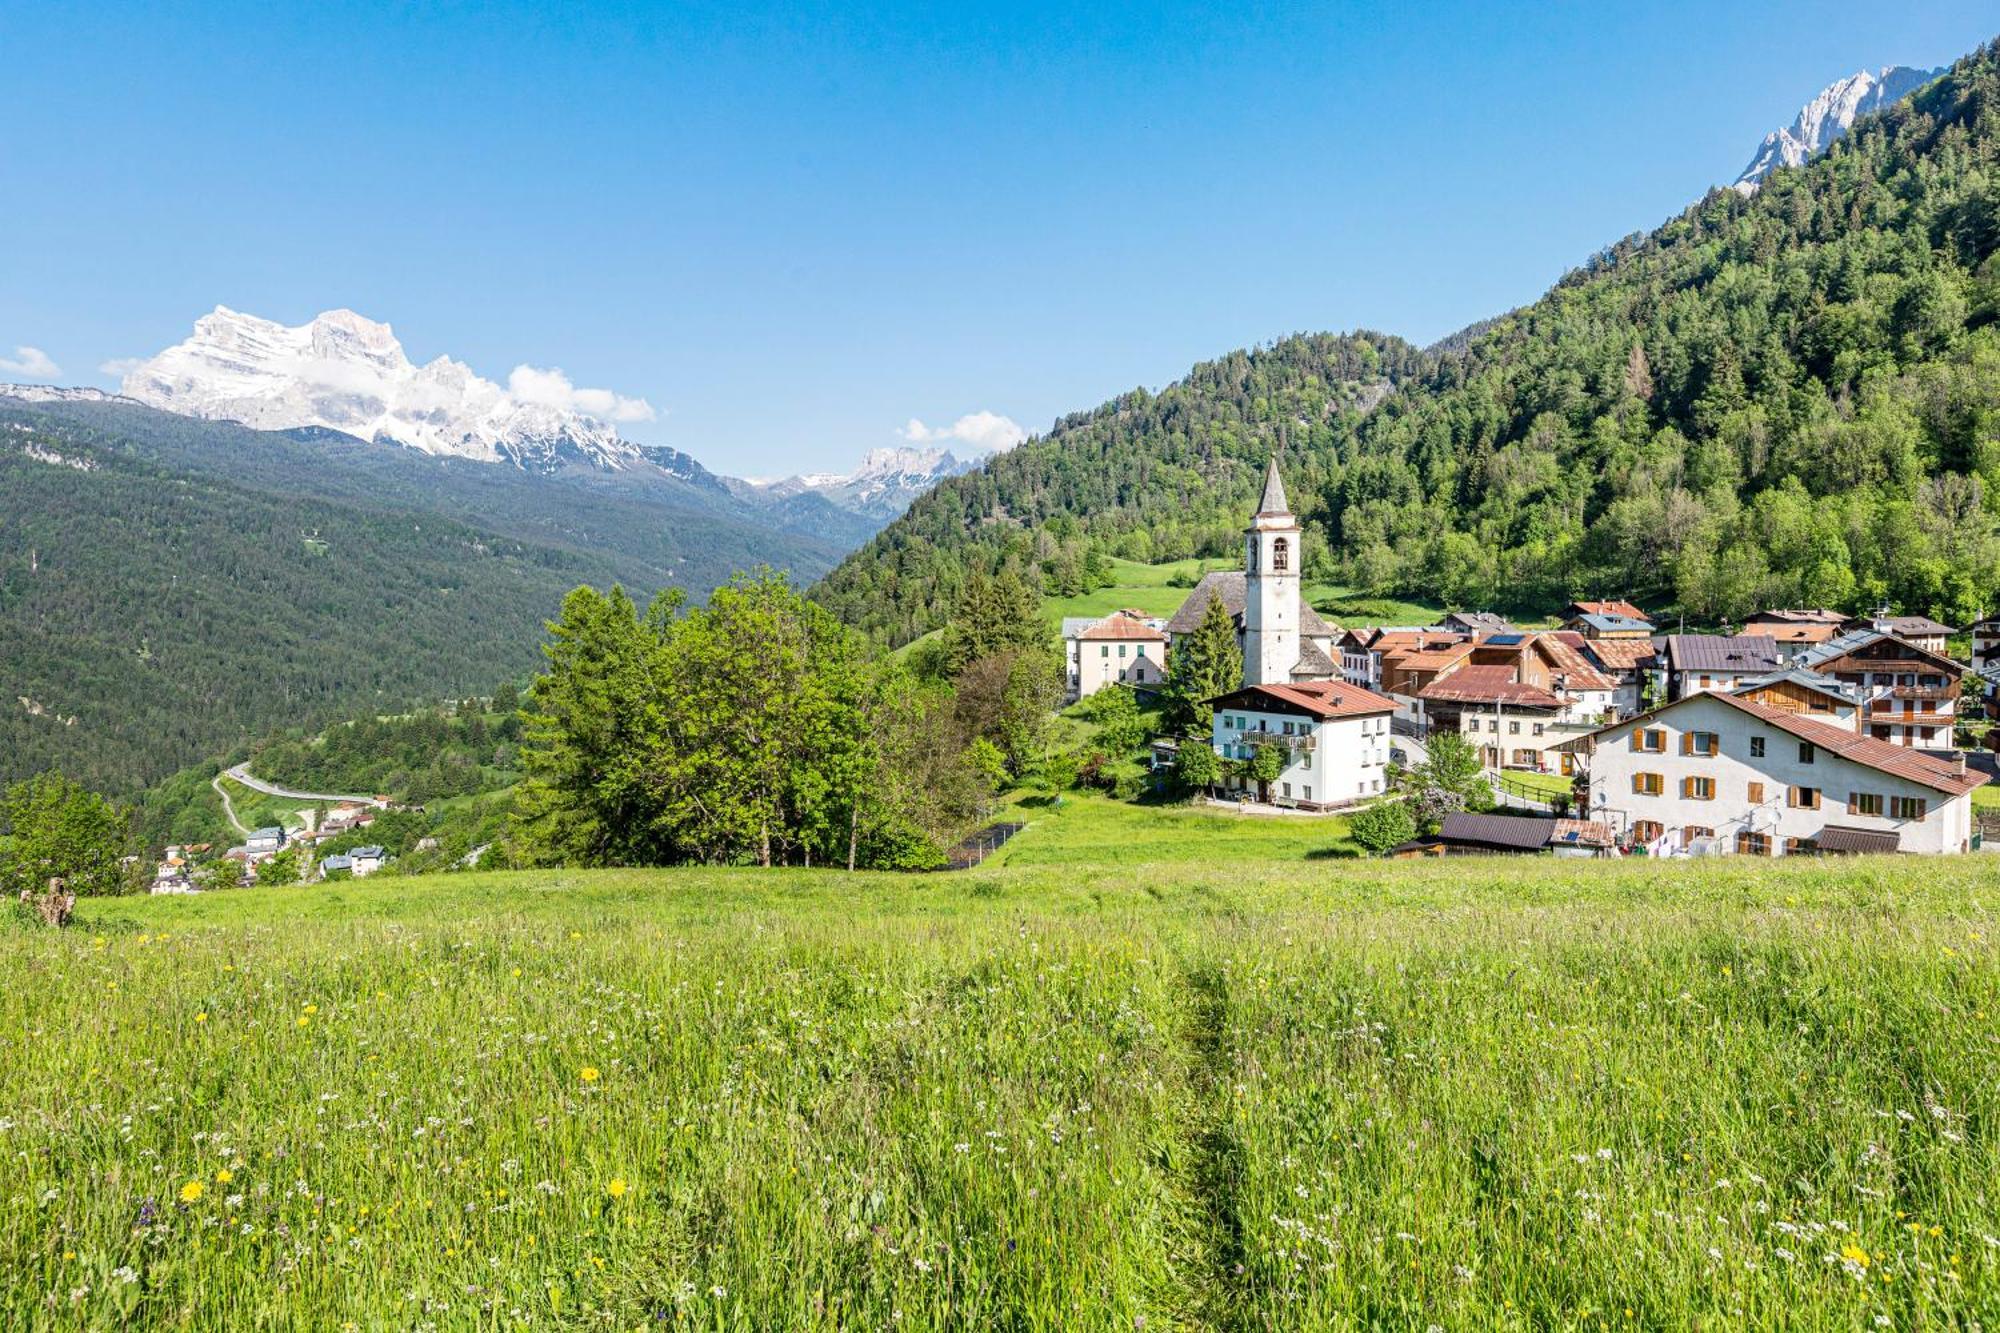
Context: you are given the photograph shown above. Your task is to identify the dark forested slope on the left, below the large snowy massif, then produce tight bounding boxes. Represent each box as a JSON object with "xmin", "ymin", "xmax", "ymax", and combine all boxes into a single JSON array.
[{"xmin": 0, "ymin": 422, "xmax": 612, "ymax": 793}]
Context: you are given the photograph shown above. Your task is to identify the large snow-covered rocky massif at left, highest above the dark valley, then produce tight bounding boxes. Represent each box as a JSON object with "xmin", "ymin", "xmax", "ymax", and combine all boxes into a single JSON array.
[{"xmin": 124, "ymin": 306, "xmax": 640, "ymax": 472}]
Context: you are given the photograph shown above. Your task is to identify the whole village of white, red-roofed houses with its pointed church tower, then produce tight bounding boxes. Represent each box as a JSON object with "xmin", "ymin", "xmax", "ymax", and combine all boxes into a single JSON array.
[{"xmin": 1062, "ymin": 458, "xmax": 2000, "ymax": 857}]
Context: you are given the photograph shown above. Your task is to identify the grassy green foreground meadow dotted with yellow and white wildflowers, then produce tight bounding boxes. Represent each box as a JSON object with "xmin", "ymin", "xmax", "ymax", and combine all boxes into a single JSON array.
[{"xmin": 0, "ymin": 797, "xmax": 2000, "ymax": 1331}]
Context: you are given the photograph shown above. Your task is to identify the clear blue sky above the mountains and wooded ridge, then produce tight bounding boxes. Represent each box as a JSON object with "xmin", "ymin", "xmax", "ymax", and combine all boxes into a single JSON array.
[{"xmin": 0, "ymin": 2, "xmax": 2000, "ymax": 474}]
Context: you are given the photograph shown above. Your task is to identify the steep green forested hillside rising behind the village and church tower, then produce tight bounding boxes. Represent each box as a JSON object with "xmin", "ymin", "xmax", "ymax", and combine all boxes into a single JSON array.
[{"xmin": 820, "ymin": 46, "xmax": 2000, "ymax": 638}]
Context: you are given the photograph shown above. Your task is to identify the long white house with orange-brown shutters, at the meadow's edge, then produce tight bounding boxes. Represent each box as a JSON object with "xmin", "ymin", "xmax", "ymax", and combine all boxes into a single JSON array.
[{"xmin": 1572, "ymin": 691, "xmax": 1986, "ymax": 857}]
